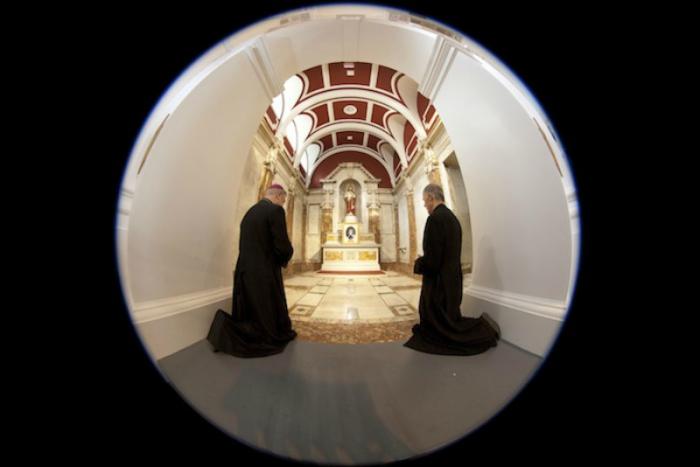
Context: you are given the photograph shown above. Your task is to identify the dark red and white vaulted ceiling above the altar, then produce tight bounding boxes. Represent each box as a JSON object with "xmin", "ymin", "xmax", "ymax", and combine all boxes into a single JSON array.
[{"xmin": 264, "ymin": 62, "xmax": 438, "ymax": 188}]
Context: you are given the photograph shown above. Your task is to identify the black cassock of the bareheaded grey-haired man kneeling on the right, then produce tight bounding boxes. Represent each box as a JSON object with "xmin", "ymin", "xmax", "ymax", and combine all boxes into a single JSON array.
[{"xmin": 404, "ymin": 204, "xmax": 500, "ymax": 355}]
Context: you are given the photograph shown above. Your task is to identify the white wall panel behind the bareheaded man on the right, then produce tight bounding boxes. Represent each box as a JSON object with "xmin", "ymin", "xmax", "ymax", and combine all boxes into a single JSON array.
[{"xmin": 435, "ymin": 53, "xmax": 571, "ymax": 303}]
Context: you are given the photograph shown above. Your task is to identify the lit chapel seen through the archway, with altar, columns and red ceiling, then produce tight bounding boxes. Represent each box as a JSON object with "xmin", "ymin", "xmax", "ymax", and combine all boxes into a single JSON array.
[{"xmin": 244, "ymin": 62, "xmax": 471, "ymax": 343}]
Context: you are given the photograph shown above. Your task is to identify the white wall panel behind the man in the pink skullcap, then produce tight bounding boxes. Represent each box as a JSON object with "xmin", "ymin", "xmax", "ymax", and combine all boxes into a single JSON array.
[{"xmin": 127, "ymin": 55, "xmax": 269, "ymax": 303}]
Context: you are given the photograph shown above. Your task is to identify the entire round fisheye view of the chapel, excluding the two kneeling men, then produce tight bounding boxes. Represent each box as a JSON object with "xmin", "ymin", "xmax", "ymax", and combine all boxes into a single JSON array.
[{"xmin": 116, "ymin": 5, "xmax": 579, "ymax": 464}]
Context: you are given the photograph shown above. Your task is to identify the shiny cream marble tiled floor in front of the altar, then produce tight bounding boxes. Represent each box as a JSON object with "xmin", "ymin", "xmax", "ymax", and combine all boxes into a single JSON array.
[{"xmin": 284, "ymin": 271, "xmax": 420, "ymax": 344}]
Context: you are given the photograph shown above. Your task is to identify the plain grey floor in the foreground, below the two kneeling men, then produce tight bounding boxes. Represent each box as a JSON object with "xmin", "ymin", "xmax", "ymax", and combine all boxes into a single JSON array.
[{"xmin": 158, "ymin": 340, "xmax": 541, "ymax": 464}]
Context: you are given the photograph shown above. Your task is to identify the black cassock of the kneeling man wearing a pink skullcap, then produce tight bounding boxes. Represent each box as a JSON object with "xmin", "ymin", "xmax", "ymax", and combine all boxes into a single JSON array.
[{"xmin": 207, "ymin": 199, "xmax": 297, "ymax": 357}]
